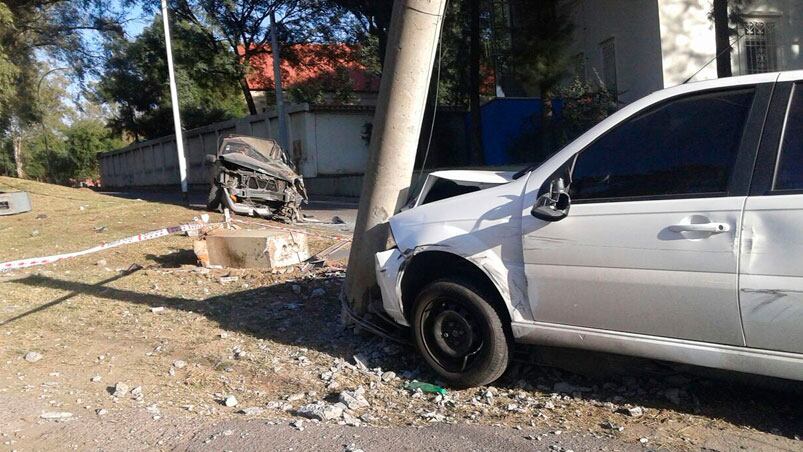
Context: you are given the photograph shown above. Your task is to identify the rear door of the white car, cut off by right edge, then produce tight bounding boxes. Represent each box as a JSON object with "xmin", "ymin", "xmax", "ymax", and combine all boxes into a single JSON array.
[{"xmin": 739, "ymin": 76, "xmax": 803, "ymax": 353}]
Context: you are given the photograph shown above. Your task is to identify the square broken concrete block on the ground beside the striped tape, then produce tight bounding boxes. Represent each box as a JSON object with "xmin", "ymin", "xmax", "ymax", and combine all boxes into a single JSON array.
[{"xmin": 206, "ymin": 229, "xmax": 309, "ymax": 269}]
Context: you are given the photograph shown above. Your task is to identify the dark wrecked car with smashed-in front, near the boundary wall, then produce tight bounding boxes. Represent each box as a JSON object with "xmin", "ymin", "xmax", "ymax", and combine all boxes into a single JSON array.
[{"xmin": 206, "ymin": 135, "xmax": 307, "ymax": 222}]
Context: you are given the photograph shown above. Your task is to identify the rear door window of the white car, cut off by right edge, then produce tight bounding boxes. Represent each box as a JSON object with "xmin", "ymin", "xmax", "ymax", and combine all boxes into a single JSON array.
[{"xmin": 773, "ymin": 83, "xmax": 803, "ymax": 190}]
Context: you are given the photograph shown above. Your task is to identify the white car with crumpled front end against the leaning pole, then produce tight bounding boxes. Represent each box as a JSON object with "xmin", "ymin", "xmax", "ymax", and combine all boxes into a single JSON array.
[{"xmin": 375, "ymin": 71, "xmax": 803, "ymax": 387}]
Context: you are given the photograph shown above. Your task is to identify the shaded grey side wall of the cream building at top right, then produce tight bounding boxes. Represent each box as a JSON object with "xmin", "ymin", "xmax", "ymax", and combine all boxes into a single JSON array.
[{"xmin": 564, "ymin": 0, "xmax": 663, "ymax": 103}]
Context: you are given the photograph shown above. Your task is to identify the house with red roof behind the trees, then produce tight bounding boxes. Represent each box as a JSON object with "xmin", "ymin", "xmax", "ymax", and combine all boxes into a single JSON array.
[{"xmin": 247, "ymin": 43, "xmax": 380, "ymax": 112}]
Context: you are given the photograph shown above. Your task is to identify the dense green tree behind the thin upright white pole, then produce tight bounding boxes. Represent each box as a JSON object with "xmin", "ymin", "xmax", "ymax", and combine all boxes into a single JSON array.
[{"xmin": 95, "ymin": 16, "xmax": 245, "ymax": 140}]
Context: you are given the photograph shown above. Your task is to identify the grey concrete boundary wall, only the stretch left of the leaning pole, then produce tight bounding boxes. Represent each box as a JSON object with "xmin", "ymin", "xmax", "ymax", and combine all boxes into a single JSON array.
[{"xmin": 98, "ymin": 104, "xmax": 373, "ymax": 192}]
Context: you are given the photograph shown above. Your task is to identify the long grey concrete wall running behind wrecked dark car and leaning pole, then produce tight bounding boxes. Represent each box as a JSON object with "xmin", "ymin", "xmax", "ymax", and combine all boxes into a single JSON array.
[{"xmin": 98, "ymin": 104, "xmax": 467, "ymax": 196}]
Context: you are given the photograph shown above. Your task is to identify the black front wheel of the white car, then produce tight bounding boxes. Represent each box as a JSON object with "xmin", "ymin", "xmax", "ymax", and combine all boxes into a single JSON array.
[{"xmin": 413, "ymin": 279, "xmax": 512, "ymax": 388}]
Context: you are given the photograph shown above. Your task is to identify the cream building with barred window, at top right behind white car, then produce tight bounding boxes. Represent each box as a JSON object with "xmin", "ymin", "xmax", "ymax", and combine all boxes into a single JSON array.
[{"xmin": 560, "ymin": 0, "xmax": 803, "ymax": 103}]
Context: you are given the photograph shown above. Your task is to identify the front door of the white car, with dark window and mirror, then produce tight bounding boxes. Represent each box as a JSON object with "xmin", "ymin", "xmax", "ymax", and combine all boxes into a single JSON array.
[{"xmin": 522, "ymin": 83, "xmax": 772, "ymax": 345}]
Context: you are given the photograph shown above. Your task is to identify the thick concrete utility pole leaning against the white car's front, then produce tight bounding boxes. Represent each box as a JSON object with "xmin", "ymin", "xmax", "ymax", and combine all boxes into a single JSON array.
[{"xmin": 344, "ymin": 0, "xmax": 446, "ymax": 315}]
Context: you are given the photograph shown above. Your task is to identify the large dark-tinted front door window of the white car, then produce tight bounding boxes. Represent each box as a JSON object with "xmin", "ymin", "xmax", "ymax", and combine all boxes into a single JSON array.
[{"xmin": 569, "ymin": 88, "xmax": 754, "ymax": 202}]
